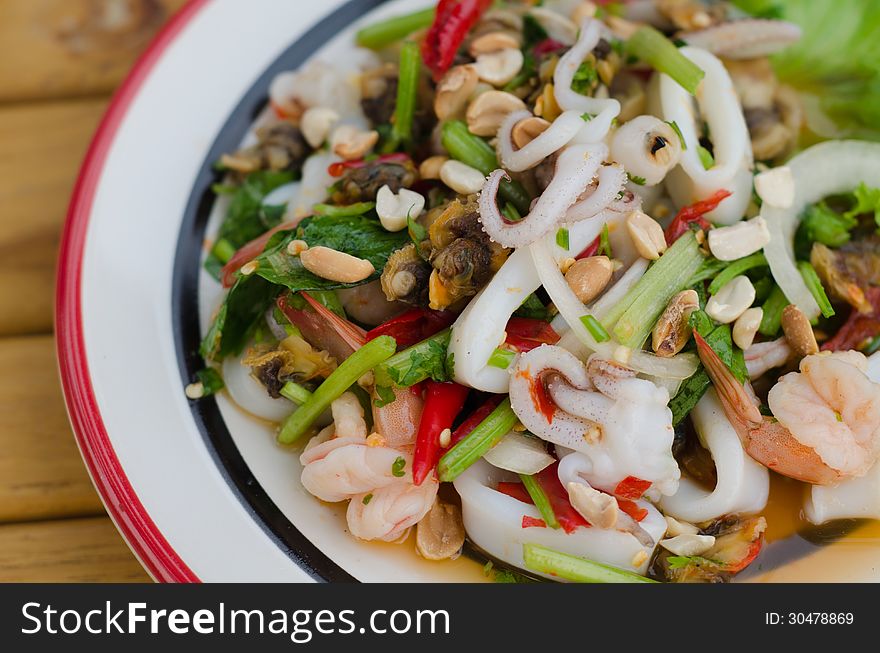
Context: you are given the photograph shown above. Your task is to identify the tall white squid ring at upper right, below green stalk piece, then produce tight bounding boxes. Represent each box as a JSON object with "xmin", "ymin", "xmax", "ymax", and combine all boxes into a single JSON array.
[{"xmin": 653, "ymin": 46, "xmax": 752, "ymax": 224}]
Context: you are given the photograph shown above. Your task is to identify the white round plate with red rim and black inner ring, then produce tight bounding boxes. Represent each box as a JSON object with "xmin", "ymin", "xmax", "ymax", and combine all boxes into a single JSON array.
[{"xmin": 57, "ymin": 0, "xmax": 878, "ymax": 581}]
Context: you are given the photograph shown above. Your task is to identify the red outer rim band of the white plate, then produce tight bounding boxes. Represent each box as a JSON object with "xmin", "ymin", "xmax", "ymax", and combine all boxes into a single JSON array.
[{"xmin": 55, "ymin": 0, "xmax": 209, "ymax": 582}]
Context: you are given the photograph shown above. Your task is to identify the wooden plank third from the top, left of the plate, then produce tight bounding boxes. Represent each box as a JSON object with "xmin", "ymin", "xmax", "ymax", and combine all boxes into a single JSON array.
[{"xmin": 0, "ymin": 336, "xmax": 103, "ymax": 522}]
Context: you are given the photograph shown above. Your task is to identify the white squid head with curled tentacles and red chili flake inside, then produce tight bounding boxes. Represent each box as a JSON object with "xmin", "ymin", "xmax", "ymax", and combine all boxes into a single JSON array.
[{"xmin": 510, "ymin": 345, "xmax": 681, "ymax": 495}]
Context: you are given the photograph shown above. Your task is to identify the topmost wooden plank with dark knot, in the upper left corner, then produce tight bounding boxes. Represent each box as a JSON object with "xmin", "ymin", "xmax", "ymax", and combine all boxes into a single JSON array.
[{"xmin": 0, "ymin": 0, "xmax": 186, "ymax": 102}]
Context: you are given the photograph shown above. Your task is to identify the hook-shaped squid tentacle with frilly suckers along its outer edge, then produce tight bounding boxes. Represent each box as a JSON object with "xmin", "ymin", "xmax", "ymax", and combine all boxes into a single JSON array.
[{"xmin": 479, "ymin": 144, "xmax": 608, "ymax": 247}]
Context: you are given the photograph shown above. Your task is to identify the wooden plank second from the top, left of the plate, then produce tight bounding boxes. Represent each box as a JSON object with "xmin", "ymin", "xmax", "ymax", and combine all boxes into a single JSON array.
[{"xmin": 0, "ymin": 98, "xmax": 107, "ymax": 336}]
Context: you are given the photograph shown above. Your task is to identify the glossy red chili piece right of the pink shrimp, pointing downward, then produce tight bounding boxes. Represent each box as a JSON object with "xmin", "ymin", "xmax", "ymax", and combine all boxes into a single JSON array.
[{"xmin": 413, "ymin": 381, "xmax": 470, "ymax": 485}]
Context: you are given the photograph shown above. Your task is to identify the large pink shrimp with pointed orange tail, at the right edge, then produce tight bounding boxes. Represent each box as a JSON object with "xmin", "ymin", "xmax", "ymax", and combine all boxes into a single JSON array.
[{"xmin": 695, "ymin": 334, "xmax": 880, "ymax": 485}]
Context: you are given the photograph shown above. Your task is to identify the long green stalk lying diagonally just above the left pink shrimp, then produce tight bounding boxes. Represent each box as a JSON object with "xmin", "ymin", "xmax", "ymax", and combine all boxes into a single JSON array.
[{"xmin": 278, "ymin": 336, "xmax": 397, "ymax": 444}]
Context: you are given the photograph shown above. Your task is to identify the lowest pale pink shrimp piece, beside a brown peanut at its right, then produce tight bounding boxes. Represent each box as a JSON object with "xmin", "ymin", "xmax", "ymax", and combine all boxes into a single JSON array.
[{"xmin": 345, "ymin": 477, "xmax": 440, "ymax": 542}]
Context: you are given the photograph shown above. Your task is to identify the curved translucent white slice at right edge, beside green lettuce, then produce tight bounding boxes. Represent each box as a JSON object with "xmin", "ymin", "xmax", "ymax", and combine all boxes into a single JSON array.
[{"xmin": 761, "ymin": 141, "xmax": 880, "ymax": 319}]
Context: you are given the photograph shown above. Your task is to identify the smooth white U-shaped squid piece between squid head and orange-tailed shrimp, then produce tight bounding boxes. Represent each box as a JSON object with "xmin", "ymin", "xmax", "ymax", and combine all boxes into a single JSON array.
[{"xmin": 660, "ymin": 390, "xmax": 770, "ymax": 522}]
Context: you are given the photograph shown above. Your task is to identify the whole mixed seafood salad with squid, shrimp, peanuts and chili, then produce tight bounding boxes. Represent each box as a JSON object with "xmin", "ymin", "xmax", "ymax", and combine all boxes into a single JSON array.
[{"xmin": 186, "ymin": 0, "xmax": 880, "ymax": 582}]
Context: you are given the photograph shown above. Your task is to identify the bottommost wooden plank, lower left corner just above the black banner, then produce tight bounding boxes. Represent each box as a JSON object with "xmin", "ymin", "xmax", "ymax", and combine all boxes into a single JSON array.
[{"xmin": 0, "ymin": 517, "xmax": 150, "ymax": 583}]
